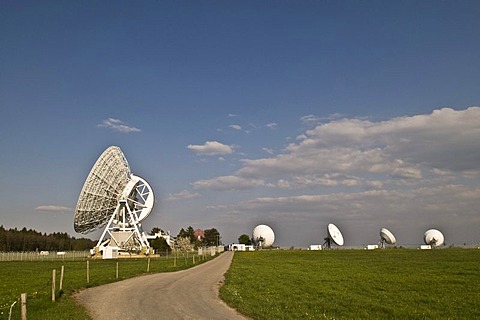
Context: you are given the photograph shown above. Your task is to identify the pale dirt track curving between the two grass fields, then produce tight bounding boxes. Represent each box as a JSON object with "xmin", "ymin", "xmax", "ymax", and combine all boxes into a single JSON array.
[{"xmin": 76, "ymin": 252, "xmax": 246, "ymax": 320}]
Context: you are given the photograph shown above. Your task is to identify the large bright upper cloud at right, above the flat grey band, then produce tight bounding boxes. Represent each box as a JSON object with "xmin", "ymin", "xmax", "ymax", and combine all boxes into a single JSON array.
[{"xmin": 192, "ymin": 107, "xmax": 480, "ymax": 192}]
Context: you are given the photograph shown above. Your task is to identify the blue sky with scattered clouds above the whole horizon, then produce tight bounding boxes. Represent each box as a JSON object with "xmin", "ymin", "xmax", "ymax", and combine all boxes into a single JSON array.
[{"xmin": 0, "ymin": 1, "xmax": 480, "ymax": 246}]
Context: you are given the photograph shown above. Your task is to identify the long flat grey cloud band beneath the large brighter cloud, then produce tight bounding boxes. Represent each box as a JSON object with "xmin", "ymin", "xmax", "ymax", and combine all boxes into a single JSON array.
[{"xmin": 225, "ymin": 185, "xmax": 480, "ymax": 222}]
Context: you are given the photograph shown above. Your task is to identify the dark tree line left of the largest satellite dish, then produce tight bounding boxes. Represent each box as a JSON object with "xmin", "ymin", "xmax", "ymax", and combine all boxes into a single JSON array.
[{"xmin": 0, "ymin": 225, "xmax": 96, "ymax": 252}]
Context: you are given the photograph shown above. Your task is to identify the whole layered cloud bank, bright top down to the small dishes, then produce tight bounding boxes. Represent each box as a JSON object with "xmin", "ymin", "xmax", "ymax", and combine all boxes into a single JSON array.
[{"xmin": 192, "ymin": 107, "xmax": 480, "ymax": 243}]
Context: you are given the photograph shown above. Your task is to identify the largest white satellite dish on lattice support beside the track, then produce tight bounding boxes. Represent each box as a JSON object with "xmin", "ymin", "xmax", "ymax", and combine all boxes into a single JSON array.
[{"xmin": 74, "ymin": 146, "xmax": 154, "ymax": 253}]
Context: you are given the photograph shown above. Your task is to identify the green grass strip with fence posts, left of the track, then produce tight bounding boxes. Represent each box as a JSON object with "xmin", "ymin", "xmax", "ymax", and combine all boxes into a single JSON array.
[{"xmin": 0, "ymin": 254, "xmax": 211, "ymax": 320}]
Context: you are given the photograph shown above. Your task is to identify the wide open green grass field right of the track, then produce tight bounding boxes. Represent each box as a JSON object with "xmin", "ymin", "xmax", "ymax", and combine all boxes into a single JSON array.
[{"xmin": 220, "ymin": 249, "xmax": 480, "ymax": 319}]
